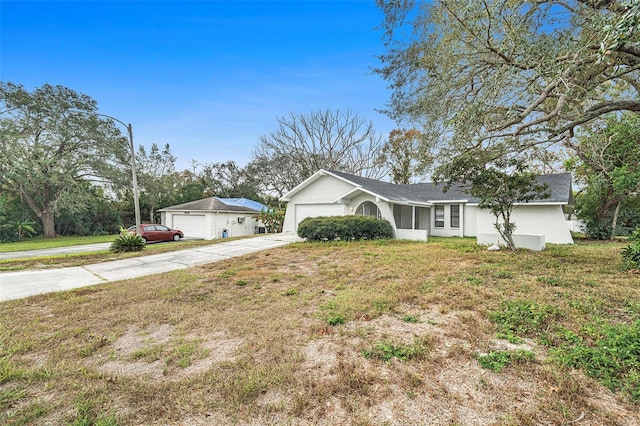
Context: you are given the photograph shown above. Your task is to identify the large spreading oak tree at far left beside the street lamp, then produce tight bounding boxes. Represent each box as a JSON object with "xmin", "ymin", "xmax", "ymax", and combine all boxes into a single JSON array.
[{"xmin": 0, "ymin": 82, "xmax": 129, "ymax": 237}]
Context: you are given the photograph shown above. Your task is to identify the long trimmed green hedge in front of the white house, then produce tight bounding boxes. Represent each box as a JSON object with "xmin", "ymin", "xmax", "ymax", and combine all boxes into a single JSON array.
[{"xmin": 298, "ymin": 216, "xmax": 393, "ymax": 241}]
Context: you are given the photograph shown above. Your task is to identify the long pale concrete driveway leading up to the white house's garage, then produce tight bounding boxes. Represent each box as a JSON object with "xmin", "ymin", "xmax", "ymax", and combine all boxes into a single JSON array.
[{"xmin": 0, "ymin": 234, "xmax": 302, "ymax": 302}]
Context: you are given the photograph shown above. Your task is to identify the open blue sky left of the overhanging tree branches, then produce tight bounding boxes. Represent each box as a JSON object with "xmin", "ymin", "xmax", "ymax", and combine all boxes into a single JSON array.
[{"xmin": 0, "ymin": 0, "xmax": 395, "ymax": 169}]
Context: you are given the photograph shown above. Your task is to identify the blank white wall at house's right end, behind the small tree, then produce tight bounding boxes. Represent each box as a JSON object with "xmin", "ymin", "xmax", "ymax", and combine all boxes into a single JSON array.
[{"xmin": 470, "ymin": 205, "xmax": 573, "ymax": 244}]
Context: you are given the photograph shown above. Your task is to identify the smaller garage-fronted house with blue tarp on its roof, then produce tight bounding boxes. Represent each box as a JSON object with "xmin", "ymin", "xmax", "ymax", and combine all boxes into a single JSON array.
[{"xmin": 158, "ymin": 197, "xmax": 267, "ymax": 240}]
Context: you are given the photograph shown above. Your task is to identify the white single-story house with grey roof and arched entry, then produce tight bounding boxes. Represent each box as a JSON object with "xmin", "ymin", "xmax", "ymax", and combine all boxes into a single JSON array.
[{"xmin": 282, "ymin": 170, "xmax": 573, "ymax": 248}]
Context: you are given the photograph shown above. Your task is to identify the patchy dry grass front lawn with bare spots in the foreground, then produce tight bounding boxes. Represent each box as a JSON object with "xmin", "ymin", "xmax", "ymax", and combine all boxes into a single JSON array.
[{"xmin": 0, "ymin": 239, "xmax": 640, "ymax": 426}]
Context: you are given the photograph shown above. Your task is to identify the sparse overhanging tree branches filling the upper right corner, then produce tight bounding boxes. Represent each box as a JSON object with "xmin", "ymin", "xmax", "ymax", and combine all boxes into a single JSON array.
[{"xmin": 376, "ymin": 0, "xmax": 640, "ymax": 158}]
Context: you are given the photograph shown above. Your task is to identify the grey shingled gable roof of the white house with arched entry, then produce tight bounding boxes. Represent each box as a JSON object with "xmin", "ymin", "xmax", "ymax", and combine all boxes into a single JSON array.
[{"xmin": 282, "ymin": 169, "xmax": 572, "ymax": 204}]
